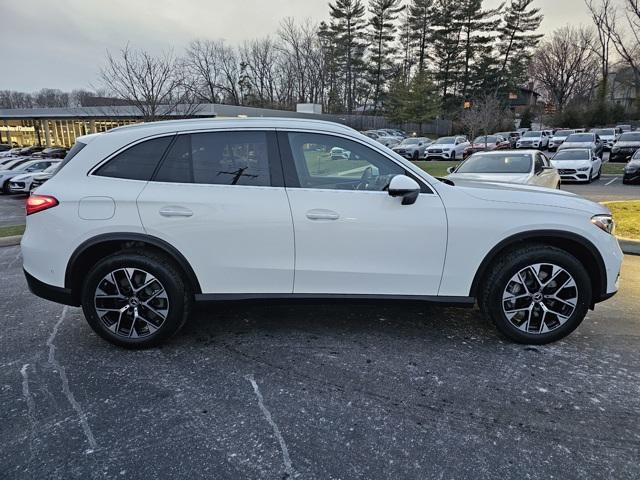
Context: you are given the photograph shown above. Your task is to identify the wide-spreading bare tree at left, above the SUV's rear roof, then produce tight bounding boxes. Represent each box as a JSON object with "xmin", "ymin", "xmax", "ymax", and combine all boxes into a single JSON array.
[{"xmin": 100, "ymin": 45, "xmax": 197, "ymax": 121}]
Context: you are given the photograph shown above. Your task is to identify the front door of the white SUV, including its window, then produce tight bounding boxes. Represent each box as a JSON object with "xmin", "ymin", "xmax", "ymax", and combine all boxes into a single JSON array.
[{"xmin": 278, "ymin": 132, "xmax": 447, "ymax": 295}]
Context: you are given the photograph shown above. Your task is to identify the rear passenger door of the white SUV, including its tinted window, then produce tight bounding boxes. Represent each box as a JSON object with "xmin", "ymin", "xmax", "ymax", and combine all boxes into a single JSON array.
[{"xmin": 138, "ymin": 130, "xmax": 294, "ymax": 294}]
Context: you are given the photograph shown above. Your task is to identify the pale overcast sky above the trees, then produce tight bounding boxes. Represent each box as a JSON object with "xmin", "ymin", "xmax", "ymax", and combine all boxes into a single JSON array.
[{"xmin": 0, "ymin": 0, "xmax": 589, "ymax": 91}]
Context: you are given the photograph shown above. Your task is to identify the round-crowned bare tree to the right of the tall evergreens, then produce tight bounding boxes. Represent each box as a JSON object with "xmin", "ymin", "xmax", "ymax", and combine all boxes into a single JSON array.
[{"xmin": 530, "ymin": 26, "xmax": 599, "ymax": 111}]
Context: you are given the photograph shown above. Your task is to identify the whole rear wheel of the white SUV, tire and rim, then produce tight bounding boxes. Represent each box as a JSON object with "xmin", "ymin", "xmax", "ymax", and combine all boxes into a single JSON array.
[{"xmin": 82, "ymin": 251, "xmax": 192, "ymax": 349}]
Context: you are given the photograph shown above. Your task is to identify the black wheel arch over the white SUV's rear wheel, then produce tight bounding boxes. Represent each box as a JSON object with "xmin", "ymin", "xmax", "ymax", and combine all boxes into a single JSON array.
[{"xmin": 64, "ymin": 233, "xmax": 202, "ymax": 301}]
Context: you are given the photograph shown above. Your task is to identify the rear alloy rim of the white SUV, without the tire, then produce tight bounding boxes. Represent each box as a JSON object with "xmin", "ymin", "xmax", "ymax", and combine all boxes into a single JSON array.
[{"xmin": 94, "ymin": 268, "xmax": 169, "ymax": 338}]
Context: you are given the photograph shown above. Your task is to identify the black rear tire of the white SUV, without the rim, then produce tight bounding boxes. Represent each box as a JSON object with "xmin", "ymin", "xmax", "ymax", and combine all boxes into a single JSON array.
[{"xmin": 82, "ymin": 250, "xmax": 193, "ymax": 349}]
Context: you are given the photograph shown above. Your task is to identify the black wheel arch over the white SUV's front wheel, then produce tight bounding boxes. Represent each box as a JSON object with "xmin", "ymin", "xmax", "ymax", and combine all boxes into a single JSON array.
[{"xmin": 469, "ymin": 230, "xmax": 607, "ymax": 304}]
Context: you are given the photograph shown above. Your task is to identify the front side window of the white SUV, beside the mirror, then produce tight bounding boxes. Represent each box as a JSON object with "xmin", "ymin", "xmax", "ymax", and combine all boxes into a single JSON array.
[{"xmin": 288, "ymin": 133, "xmax": 406, "ymax": 191}]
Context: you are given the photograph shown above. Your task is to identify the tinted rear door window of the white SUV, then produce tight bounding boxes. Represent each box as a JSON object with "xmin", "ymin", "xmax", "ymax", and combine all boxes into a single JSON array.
[{"xmin": 154, "ymin": 131, "xmax": 271, "ymax": 186}]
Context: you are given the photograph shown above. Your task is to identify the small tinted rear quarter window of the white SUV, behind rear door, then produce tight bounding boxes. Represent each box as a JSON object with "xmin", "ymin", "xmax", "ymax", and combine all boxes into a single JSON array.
[{"xmin": 94, "ymin": 137, "xmax": 173, "ymax": 180}]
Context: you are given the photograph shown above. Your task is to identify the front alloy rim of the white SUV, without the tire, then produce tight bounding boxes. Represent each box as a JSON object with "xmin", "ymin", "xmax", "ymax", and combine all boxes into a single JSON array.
[{"xmin": 502, "ymin": 263, "xmax": 578, "ymax": 335}]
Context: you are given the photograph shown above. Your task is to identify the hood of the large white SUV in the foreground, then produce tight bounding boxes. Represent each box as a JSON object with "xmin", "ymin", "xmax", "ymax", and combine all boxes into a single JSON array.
[{"xmin": 454, "ymin": 180, "xmax": 609, "ymax": 215}]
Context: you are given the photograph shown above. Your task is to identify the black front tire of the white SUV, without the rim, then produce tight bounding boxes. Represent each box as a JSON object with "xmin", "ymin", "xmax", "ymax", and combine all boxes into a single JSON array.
[{"xmin": 478, "ymin": 244, "xmax": 593, "ymax": 345}]
